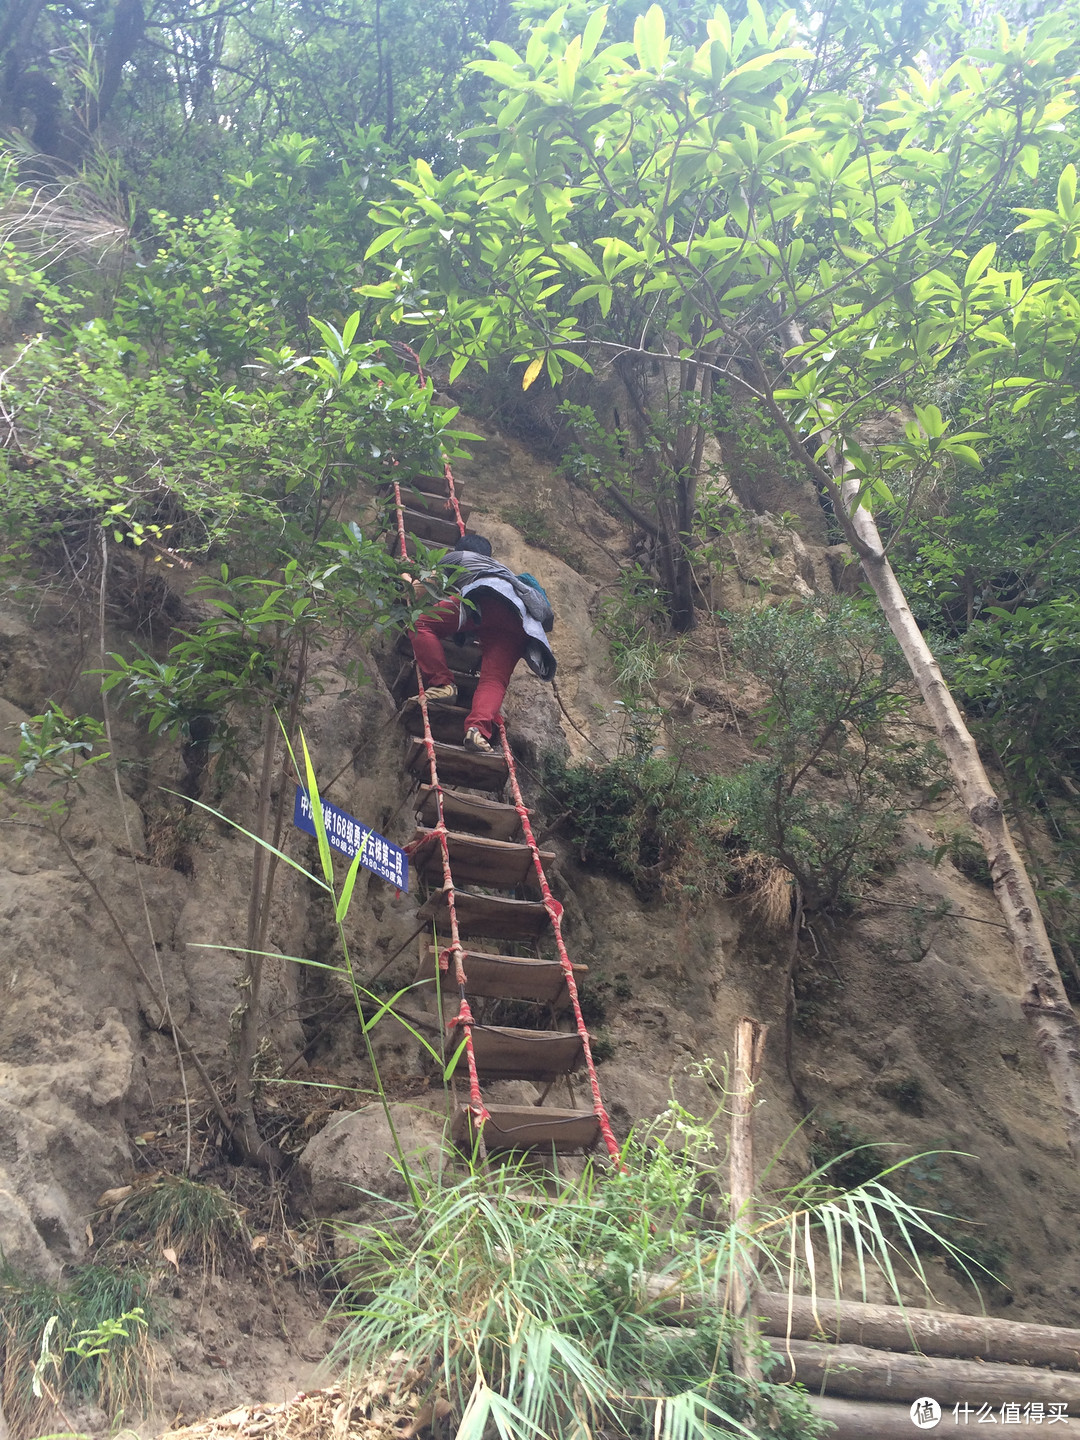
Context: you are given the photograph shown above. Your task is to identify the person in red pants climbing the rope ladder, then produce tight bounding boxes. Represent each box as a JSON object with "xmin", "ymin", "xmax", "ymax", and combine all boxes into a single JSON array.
[{"xmin": 403, "ymin": 534, "xmax": 556, "ymax": 755}]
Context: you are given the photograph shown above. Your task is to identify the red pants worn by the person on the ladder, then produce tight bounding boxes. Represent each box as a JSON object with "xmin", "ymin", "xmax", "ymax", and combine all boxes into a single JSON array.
[{"xmin": 412, "ymin": 590, "xmax": 526, "ymax": 740}]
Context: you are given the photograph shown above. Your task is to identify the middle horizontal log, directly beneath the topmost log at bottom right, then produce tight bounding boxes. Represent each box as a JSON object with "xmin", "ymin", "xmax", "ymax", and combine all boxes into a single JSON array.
[{"xmin": 769, "ymin": 1341, "xmax": 1080, "ymax": 1416}]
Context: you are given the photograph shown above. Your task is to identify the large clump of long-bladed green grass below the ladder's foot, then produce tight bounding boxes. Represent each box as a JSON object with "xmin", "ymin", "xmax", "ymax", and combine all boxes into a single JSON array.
[{"xmin": 334, "ymin": 1112, "xmax": 973, "ymax": 1440}]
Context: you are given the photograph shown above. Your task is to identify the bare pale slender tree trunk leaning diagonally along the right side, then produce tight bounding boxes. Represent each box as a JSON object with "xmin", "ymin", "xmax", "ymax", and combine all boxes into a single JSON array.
[{"xmin": 841, "ymin": 478, "xmax": 1080, "ymax": 1161}]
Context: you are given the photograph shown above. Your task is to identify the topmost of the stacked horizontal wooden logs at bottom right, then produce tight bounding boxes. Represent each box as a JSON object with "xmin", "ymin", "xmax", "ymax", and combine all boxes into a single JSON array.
[{"xmin": 754, "ymin": 1292, "xmax": 1080, "ymax": 1369}]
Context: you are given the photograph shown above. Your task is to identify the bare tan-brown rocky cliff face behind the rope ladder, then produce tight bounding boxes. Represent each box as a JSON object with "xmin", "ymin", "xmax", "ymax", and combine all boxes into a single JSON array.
[{"xmin": 0, "ymin": 414, "xmax": 1080, "ymax": 1417}]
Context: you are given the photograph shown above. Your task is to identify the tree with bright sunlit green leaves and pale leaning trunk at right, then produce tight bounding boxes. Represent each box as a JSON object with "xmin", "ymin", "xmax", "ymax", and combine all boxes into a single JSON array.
[{"xmin": 361, "ymin": 3, "xmax": 1080, "ymax": 1155}]
